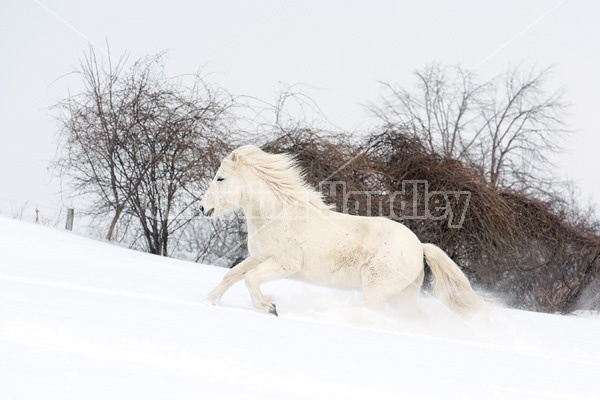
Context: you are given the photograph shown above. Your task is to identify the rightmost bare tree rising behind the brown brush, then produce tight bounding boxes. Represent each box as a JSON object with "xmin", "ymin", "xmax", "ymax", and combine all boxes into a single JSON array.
[{"xmin": 471, "ymin": 68, "xmax": 568, "ymax": 186}]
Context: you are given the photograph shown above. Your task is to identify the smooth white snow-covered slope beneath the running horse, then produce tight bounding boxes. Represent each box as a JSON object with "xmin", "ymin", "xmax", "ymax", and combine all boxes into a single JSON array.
[{"xmin": 0, "ymin": 217, "xmax": 600, "ymax": 400}]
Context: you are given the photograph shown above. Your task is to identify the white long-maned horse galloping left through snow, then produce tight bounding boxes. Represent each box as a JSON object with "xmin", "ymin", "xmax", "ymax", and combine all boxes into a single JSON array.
[{"xmin": 200, "ymin": 145, "xmax": 483, "ymax": 315}]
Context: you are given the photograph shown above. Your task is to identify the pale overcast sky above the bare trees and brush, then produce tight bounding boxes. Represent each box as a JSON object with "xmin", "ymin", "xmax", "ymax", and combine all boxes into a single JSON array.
[{"xmin": 0, "ymin": 0, "xmax": 600, "ymax": 220}]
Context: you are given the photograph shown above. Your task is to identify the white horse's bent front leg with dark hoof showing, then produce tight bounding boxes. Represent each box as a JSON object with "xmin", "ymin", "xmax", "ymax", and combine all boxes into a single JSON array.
[{"xmin": 245, "ymin": 258, "xmax": 299, "ymax": 315}]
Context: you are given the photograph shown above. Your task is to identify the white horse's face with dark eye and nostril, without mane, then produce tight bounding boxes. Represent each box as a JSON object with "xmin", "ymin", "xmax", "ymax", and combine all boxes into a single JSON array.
[{"xmin": 200, "ymin": 147, "xmax": 244, "ymax": 217}]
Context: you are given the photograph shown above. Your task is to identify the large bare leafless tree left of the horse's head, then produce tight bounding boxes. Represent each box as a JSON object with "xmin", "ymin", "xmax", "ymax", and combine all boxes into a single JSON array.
[{"xmin": 55, "ymin": 49, "xmax": 233, "ymax": 256}]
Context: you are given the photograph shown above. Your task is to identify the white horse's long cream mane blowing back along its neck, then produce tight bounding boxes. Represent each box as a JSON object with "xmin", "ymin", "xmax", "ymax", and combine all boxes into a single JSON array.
[{"xmin": 226, "ymin": 145, "xmax": 330, "ymax": 209}]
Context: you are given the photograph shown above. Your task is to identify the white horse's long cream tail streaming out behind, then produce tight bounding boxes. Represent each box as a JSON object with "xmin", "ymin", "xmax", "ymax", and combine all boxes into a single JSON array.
[{"xmin": 423, "ymin": 243, "xmax": 485, "ymax": 315}]
